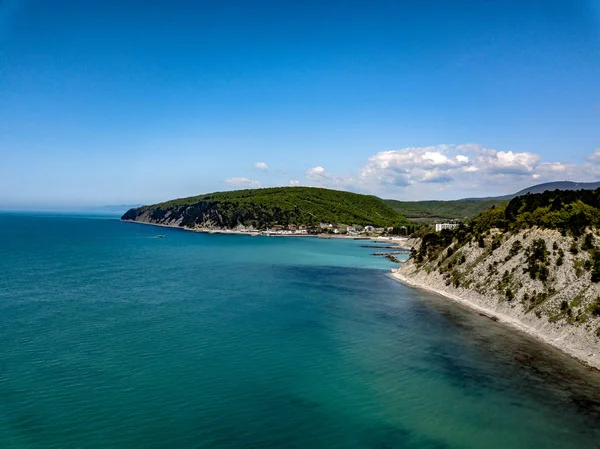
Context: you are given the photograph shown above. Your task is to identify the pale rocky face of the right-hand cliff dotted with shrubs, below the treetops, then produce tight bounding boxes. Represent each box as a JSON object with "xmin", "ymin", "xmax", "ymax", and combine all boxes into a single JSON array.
[{"xmin": 393, "ymin": 228, "xmax": 600, "ymax": 369}]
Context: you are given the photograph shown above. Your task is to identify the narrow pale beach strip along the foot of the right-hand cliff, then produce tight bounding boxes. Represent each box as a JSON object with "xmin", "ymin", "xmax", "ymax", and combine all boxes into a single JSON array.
[{"xmin": 390, "ymin": 268, "xmax": 600, "ymax": 372}]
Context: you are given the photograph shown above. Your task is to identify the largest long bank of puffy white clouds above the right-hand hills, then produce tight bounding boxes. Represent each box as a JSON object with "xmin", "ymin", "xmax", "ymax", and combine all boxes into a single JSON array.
[{"xmin": 306, "ymin": 144, "xmax": 600, "ymax": 199}]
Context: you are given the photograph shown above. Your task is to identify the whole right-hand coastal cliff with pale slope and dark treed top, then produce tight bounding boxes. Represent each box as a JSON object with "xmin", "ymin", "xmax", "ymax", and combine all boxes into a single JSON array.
[{"xmin": 393, "ymin": 190, "xmax": 600, "ymax": 369}]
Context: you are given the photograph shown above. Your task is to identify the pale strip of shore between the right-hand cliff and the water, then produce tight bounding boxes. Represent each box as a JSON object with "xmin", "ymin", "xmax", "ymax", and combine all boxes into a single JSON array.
[{"xmin": 391, "ymin": 269, "xmax": 600, "ymax": 370}]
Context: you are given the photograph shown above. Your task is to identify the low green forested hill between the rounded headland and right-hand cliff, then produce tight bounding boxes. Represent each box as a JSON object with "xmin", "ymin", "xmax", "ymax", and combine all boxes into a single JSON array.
[{"xmin": 384, "ymin": 199, "xmax": 508, "ymax": 220}]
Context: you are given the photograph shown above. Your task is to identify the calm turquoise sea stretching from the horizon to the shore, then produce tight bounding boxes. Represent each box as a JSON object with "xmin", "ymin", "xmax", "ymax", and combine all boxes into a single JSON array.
[{"xmin": 0, "ymin": 213, "xmax": 600, "ymax": 449}]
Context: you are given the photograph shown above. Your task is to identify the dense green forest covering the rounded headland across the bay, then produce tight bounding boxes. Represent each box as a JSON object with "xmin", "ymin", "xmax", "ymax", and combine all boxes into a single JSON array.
[{"xmin": 122, "ymin": 187, "xmax": 410, "ymax": 229}]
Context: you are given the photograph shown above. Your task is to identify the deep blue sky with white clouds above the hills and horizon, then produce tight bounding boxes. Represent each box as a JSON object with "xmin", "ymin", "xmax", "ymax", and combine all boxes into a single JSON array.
[{"xmin": 0, "ymin": 0, "xmax": 600, "ymax": 208}]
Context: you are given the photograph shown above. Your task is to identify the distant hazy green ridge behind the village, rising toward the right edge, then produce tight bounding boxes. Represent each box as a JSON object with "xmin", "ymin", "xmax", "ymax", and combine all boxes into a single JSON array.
[{"xmin": 384, "ymin": 181, "xmax": 600, "ymax": 221}]
